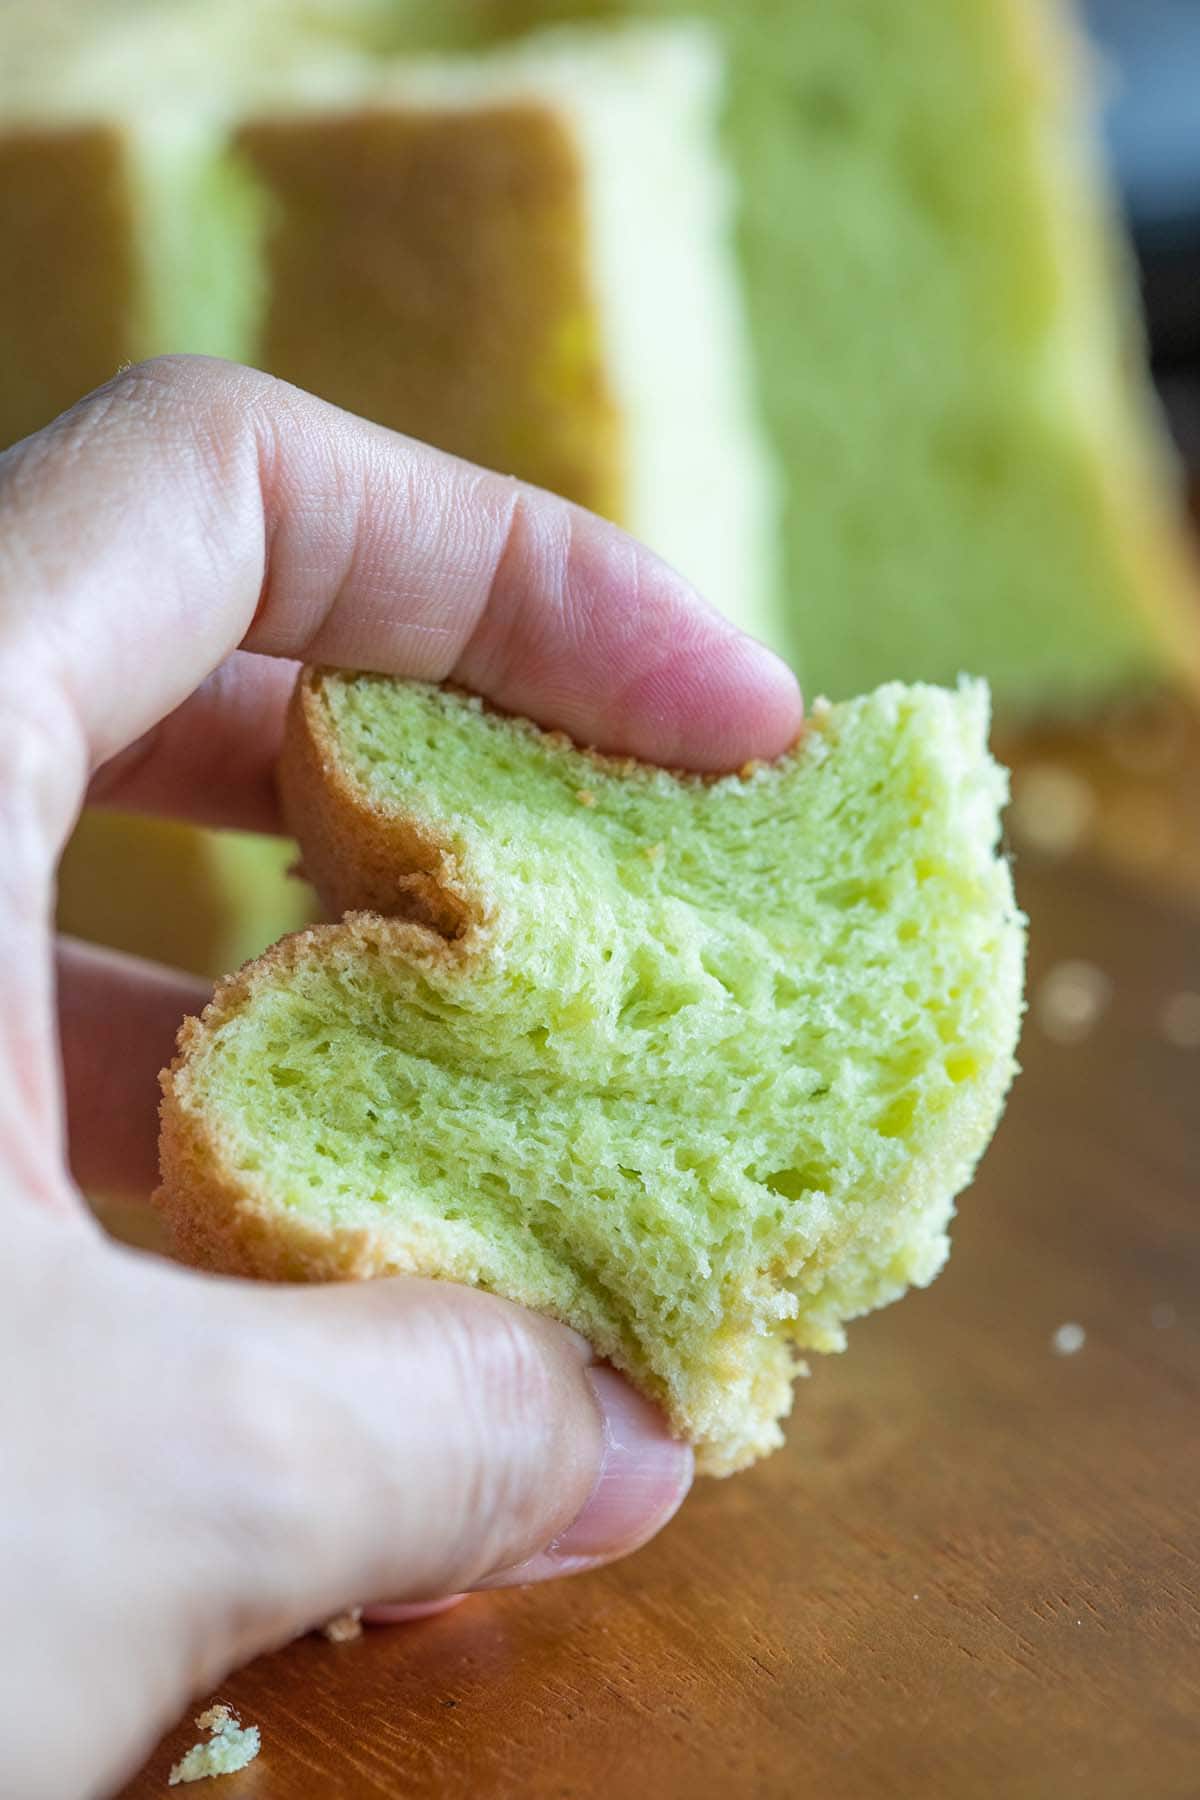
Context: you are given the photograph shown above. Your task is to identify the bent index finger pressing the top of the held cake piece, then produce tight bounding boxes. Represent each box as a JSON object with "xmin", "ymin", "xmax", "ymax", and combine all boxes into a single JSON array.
[{"xmin": 0, "ymin": 358, "xmax": 801, "ymax": 864}]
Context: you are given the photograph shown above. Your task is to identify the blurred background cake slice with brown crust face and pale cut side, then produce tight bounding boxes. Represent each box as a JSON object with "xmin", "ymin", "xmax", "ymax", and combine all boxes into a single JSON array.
[{"xmin": 234, "ymin": 25, "xmax": 779, "ymax": 632}]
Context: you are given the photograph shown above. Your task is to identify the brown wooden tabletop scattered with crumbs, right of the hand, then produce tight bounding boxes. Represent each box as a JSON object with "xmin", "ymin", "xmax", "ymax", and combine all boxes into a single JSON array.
[{"xmin": 115, "ymin": 752, "xmax": 1200, "ymax": 1800}]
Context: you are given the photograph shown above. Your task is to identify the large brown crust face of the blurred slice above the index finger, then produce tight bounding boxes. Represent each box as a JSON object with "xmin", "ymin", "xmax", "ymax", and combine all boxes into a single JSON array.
[{"xmin": 236, "ymin": 103, "xmax": 624, "ymax": 518}]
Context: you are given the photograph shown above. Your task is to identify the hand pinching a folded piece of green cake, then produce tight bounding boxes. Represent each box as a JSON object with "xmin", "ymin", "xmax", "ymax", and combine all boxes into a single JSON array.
[{"xmin": 0, "ymin": 360, "xmax": 799, "ymax": 1800}]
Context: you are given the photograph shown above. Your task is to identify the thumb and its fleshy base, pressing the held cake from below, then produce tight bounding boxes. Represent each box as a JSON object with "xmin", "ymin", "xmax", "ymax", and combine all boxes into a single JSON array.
[{"xmin": 0, "ymin": 1209, "xmax": 691, "ymax": 1795}]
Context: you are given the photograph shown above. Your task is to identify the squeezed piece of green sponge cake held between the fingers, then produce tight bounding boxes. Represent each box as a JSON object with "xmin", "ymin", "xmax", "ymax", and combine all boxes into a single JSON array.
[{"xmin": 158, "ymin": 673, "xmax": 1024, "ymax": 1474}]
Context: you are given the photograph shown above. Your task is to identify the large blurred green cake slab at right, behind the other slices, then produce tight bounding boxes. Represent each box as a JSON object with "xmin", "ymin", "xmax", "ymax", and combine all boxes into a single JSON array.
[{"xmin": 417, "ymin": 0, "xmax": 1200, "ymax": 715}]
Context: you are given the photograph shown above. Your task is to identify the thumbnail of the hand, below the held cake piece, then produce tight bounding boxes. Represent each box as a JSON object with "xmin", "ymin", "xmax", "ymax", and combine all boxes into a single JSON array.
[{"xmin": 477, "ymin": 1368, "xmax": 693, "ymax": 1588}]
